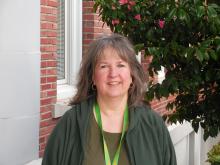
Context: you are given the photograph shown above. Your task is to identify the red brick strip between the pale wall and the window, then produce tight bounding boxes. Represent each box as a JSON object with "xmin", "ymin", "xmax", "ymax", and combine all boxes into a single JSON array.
[{"xmin": 39, "ymin": 0, "xmax": 58, "ymax": 157}]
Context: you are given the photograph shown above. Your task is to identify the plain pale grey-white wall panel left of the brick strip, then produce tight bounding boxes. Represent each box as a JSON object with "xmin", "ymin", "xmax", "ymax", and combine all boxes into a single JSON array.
[{"xmin": 0, "ymin": 0, "xmax": 40, "ymax": 165}]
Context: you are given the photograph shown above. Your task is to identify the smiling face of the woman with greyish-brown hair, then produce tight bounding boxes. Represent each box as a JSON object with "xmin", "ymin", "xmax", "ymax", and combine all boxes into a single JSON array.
[{"xmin": 93, "ymin": 48, "xmax": 132, "ymax": 98}]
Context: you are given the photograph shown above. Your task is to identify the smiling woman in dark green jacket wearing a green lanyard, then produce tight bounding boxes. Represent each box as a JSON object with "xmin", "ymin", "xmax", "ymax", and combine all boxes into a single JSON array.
[{"xmin": 42, "ymin": 34, "xmax": 176, "ymax": 165}]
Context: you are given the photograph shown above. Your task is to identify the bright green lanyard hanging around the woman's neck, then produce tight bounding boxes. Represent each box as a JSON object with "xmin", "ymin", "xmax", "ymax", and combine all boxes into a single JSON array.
[{"xmin": 93, "ymin": 103, "xmax": 128, "ymax": 165}]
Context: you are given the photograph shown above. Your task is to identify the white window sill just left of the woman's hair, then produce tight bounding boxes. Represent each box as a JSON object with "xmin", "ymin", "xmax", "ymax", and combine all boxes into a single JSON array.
[{"xmin": 52, "ymin": 84, "xmax": 76, "ymax": 118}]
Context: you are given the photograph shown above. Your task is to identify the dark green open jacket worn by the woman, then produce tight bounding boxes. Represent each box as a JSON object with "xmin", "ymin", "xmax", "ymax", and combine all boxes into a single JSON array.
[{"xmin": 42, "ymin": 97, "xmax": 176, "ymax": 165}]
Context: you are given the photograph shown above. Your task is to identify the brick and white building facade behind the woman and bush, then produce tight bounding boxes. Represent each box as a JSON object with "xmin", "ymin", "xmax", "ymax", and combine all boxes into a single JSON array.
[{"xmin": 0, "ymin": 0, "xmax": 220, "ymax": 165}]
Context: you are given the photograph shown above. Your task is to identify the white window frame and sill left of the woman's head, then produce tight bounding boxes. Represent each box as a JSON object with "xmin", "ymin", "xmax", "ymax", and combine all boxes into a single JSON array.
[{"xmin": 53, "ymin": 0, "xmax": 82, "ymax": 118}]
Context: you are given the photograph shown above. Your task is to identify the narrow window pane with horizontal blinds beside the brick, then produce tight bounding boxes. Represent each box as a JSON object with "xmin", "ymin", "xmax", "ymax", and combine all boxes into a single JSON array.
[{"xmin": 57, "ymin": 0, "xmax": 65, "ymax": 80}]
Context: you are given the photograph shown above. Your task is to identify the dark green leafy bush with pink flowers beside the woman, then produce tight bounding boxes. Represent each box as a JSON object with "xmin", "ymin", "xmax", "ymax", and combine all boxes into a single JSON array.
[{"xmin": 94, "ymin": 0, "xmax": 220, "ymax": 139}]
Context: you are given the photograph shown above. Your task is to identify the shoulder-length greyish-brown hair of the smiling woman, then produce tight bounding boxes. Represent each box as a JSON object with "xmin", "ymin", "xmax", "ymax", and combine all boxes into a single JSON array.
[{"xmin": 70, "ymin": 34, "xmax": 146, "ymax": 106}]
